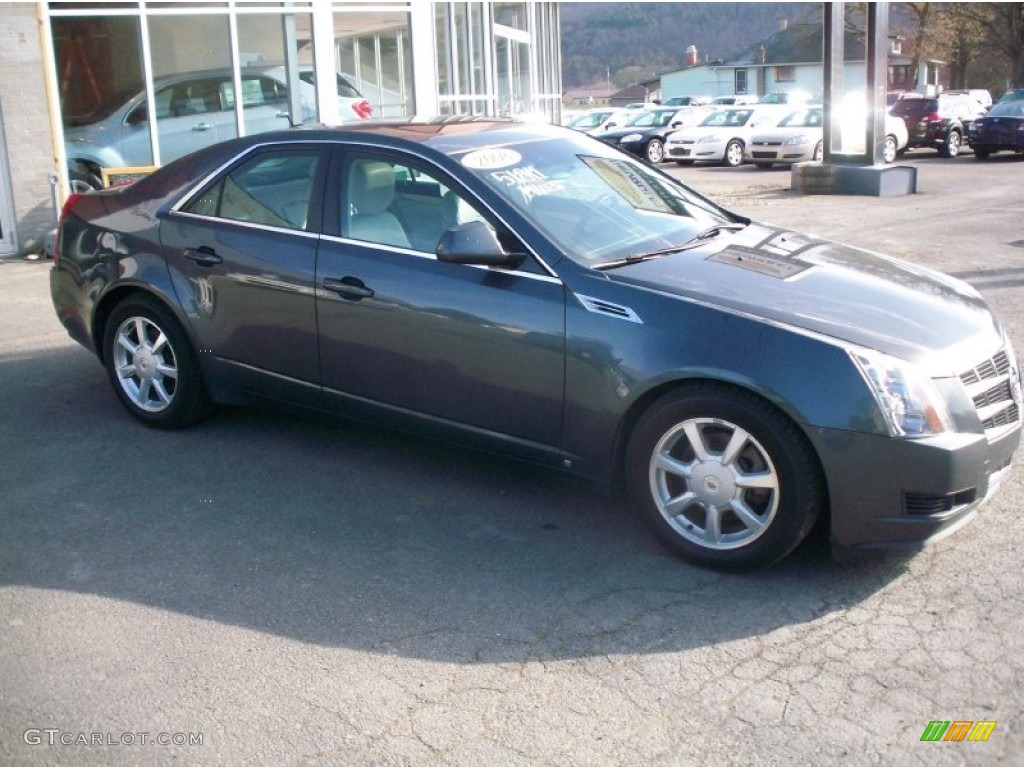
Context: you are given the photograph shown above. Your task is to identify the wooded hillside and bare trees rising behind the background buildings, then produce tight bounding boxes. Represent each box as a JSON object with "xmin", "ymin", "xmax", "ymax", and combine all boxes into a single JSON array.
[{"xmin": 560, "ymin": 2, "xmax": 1024, "ymax": 94}]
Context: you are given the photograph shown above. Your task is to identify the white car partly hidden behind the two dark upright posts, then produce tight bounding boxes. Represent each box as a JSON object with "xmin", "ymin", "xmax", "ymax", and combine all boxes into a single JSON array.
[{"xmin": 744, "ymin": 103, "xmax": 907, "ymax": 168}]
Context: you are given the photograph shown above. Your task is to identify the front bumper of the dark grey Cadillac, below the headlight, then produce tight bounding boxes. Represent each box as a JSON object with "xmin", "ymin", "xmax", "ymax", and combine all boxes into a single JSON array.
[{"xmin": 815, "ymin": 424, "xmax": 1021, "ymax": 550}]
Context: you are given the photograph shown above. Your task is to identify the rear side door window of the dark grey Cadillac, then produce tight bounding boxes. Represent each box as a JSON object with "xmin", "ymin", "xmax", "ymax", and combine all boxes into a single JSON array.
[{"xmin": 182, "ymin": 150, "xmax": 319, "ymax": 229}]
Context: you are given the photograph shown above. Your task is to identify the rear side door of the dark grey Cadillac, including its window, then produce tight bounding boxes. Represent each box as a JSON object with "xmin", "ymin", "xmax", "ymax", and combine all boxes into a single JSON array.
[{"xmin": 161, "ymin": 144, "xmax": 324, "ymax": 407}]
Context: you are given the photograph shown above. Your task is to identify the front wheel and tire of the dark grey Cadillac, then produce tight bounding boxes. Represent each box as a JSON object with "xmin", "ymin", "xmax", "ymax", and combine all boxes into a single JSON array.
[{"xmin": 626, "ymin": 383, "xmax": 825, "ymax": 570}]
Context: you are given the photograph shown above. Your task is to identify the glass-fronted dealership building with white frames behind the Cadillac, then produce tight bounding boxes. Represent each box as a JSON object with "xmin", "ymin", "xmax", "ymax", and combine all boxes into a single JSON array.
[{"xmin": 0, "ymin": 0, "xmax": 561, "ymax": 257}]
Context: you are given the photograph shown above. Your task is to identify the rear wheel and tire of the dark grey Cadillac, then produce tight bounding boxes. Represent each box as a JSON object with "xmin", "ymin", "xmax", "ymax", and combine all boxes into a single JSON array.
[{"xmin": 103, "ymin": 295, "xmax": 209, "ymax": 429}]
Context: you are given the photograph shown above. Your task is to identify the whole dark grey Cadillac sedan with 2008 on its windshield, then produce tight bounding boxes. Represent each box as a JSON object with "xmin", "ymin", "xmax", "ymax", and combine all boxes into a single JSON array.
[{"xmin": 51, "ymin": 121, "xmax": 1021, "ymax": 569}]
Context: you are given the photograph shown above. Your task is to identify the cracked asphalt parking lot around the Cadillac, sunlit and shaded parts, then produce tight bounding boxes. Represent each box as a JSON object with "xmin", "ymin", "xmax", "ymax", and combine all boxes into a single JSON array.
[{"xmin": 0, "ymin": 151, "xmax": 1024, "ymax": 765}]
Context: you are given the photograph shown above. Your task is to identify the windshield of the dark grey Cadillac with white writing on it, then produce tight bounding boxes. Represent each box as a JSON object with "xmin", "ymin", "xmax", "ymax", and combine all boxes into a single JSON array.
[{"xmin": 456, "ymin": 133, "xmax": 736, "ymax": 267}]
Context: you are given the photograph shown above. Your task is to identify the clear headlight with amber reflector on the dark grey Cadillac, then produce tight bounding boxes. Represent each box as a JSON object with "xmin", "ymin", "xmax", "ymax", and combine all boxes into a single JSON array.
[{"xmin": 850, "ymin": 349, "xmax": 953, "ymax": 437}]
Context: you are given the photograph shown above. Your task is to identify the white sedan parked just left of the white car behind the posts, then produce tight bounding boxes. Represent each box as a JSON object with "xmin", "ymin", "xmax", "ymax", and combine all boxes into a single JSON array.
[{"xmin": 665, "ymin": 105, "xmax": 784, "ymax": 168}]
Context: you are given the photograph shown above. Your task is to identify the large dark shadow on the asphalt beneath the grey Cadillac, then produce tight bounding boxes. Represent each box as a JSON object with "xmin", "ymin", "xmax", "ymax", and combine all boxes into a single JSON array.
[{"xmin": 0, "ymin": 346, "xmax": 907, "ymax": 664}]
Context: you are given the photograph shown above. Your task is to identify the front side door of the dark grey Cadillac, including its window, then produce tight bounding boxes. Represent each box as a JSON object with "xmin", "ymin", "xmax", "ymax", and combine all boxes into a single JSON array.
[{"xmin": 316, "ymin": 153, "xmax": 565, "ymax": 456}]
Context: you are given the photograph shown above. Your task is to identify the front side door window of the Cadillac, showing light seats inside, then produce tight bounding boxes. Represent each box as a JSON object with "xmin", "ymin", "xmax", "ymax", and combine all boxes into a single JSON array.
[{"xmin": 341, "ymin": 155, "xmax": 494, "ymax": 254}]
